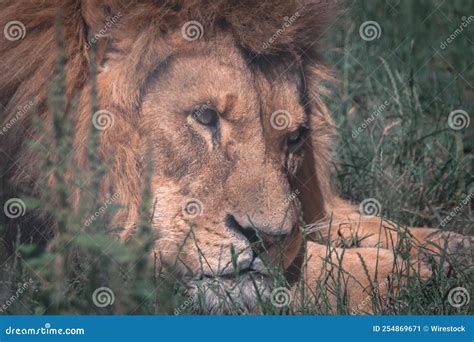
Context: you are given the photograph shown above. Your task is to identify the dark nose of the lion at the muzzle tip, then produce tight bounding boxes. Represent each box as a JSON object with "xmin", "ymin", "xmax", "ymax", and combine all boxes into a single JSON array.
[{"xmin": 225, "ymin": 214, "xmax": 289, "ymax": 249}]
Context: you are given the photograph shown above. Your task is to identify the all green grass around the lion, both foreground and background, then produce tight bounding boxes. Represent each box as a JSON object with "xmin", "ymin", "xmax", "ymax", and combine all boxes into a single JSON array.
[{"xmin": 0, "ymin": 0, "xmax": 474, "ymax": 314}]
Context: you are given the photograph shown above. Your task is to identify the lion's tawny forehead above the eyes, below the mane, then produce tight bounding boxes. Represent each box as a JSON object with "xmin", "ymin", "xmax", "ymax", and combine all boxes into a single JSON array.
[{"xmin": 143, "ymin": 44, "xmax": 305, "ymax": 127}]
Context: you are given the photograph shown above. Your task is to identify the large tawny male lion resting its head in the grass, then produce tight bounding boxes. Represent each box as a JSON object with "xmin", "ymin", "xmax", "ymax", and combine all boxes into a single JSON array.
[{"xmin": 0, "ymin": 0, "xmax": 469, "ymax": 312}]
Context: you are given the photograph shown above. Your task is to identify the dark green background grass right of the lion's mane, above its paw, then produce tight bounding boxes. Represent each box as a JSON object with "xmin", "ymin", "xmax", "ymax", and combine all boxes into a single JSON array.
[{"xmin": 326, "ymin": 1, "xmax": 474, "ymax": 234}]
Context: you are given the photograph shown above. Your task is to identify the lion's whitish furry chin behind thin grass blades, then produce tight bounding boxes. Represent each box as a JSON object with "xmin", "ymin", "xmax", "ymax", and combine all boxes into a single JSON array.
[{"xmin": 188, "ymin": 272, "xmax": 272, "ymax": 315}]
